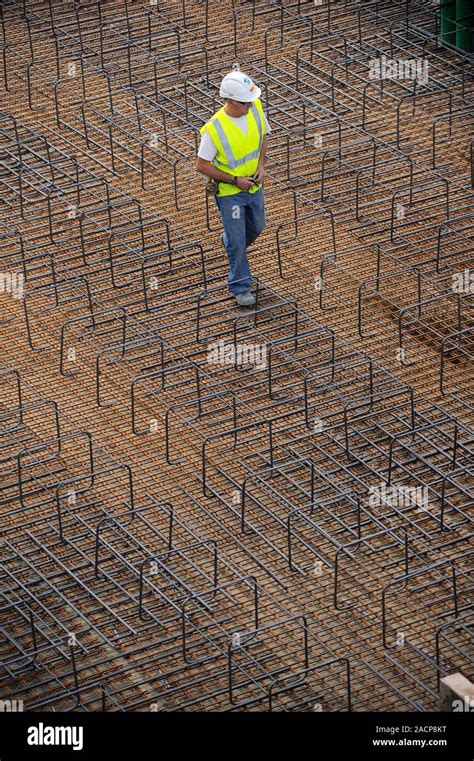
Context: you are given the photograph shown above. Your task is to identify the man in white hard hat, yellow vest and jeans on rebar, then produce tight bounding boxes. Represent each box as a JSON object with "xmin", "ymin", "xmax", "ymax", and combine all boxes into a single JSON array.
[{"xmin": 196, "ymin": 70, "xmax": 270, "ymax": 307}]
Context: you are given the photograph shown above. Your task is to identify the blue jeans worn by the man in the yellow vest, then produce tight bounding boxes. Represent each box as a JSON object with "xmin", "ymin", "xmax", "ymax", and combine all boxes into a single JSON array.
[{"xmin": 216, "ymin": 188, "xmax": 265, "ymax": 296}]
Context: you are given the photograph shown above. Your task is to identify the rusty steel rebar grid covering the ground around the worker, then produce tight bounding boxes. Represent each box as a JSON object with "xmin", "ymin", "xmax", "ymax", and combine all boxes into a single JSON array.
[{"xmin": 0, "ymin": 1, "xmax": 472, "ymax": 711}]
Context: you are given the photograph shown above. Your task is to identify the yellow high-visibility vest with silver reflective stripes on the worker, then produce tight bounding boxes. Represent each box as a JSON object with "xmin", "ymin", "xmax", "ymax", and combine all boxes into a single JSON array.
[{"xmin": 199, "ymin": 98, "xmax": 266, "ymax": 196}]
